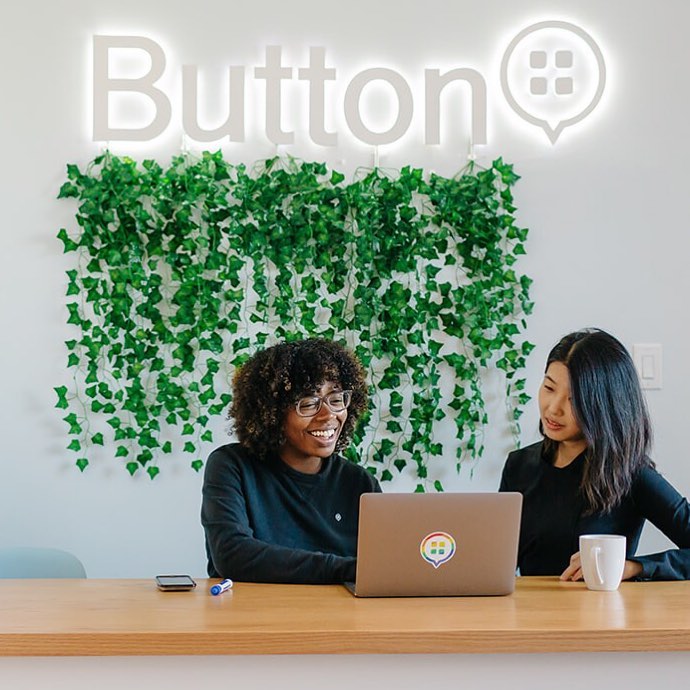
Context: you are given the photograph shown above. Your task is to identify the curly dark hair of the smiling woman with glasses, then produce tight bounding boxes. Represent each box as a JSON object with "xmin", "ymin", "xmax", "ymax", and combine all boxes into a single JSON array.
[{"xmin": 229, "ymin": 338, "xmax": 369, "ymax": 459}]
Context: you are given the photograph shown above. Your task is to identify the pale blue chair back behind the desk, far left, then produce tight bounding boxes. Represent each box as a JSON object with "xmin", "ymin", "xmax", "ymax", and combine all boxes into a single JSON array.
[{"xmin": 0, "ymin": 546, "xmax": 86, "ymax": 579}]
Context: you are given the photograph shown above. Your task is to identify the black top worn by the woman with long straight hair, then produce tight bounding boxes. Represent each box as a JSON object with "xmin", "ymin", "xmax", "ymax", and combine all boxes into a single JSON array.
[{"xmin": 499, "ymin": 443, "xmax": 690, "ymax": 580}]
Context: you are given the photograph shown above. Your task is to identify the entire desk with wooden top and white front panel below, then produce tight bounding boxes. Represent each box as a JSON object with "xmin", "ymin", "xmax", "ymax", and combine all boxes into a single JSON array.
[{"xmin": 0, "ymin": 578, "xmax": 690, "ymax": 690}]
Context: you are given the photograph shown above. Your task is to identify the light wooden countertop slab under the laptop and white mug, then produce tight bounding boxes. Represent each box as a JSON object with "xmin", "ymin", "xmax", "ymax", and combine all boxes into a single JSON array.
[{"xmin": 0, "ymin": 577, "xmax": 690, "ymax": 656}]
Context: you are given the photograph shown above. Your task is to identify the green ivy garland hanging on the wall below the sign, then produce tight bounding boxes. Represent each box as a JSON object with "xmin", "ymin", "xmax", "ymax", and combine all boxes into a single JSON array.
[{"xmin": 55, "ymin": 152, "xmax": 533, "ymax": 491}]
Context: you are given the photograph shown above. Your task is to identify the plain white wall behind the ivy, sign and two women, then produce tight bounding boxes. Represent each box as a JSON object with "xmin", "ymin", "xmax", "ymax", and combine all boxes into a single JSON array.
[{"xmin": 0, "ymin": 0, "xmax": 690, "ymax": 577}]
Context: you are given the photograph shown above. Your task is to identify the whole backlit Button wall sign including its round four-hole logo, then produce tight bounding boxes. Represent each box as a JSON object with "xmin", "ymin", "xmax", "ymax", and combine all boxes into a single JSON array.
[{"xmin": 93, "ymin": 21, "xmax": 606, "ymax": 146}]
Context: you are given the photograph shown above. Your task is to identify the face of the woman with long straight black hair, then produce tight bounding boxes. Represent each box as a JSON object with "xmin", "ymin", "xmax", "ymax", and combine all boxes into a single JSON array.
[{"xmin": 539, "ymin": 362, "xmax": 587, "ymax": 455}]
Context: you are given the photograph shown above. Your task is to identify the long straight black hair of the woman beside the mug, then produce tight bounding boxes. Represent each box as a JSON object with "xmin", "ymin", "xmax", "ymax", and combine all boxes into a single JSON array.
[{"xmin": 540, "ymin": 328, "xmax": 653, "ymax": 513}]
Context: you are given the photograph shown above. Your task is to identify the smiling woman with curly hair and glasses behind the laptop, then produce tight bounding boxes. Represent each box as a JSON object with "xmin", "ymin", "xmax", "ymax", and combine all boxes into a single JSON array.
[{"xmin": 201, "ymin": 339, "xmax": 381, "ymax": 584}]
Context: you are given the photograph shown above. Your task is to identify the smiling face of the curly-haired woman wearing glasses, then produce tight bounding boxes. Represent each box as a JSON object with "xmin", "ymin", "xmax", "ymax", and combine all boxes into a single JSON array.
[{"xmin": 279, "ymin": 381, "xmax": 347, "ymax": 474}]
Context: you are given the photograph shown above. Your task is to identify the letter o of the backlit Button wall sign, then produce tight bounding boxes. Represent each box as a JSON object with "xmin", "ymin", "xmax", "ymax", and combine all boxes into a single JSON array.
[{"xmin": 345, "ymin": 67, "xmax": 414, "ymax": 145}]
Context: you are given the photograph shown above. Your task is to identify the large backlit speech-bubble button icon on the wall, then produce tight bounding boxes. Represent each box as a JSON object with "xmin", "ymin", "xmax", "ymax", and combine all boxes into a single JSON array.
[{"xmin": 501, "ymin": 21, "xmax": 606, "ymax": 144}]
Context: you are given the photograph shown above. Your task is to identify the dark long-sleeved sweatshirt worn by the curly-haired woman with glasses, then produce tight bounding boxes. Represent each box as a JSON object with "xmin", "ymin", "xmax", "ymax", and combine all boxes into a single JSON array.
[{"xmin": 201, "ymin": 443, "xmax": 381, "ymax": 584}]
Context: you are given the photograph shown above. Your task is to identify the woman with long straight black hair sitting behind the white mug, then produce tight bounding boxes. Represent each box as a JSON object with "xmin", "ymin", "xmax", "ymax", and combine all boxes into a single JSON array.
[{"xmin": 500, "ymin": 329, "xmax": 690, "ymax": 580}]
